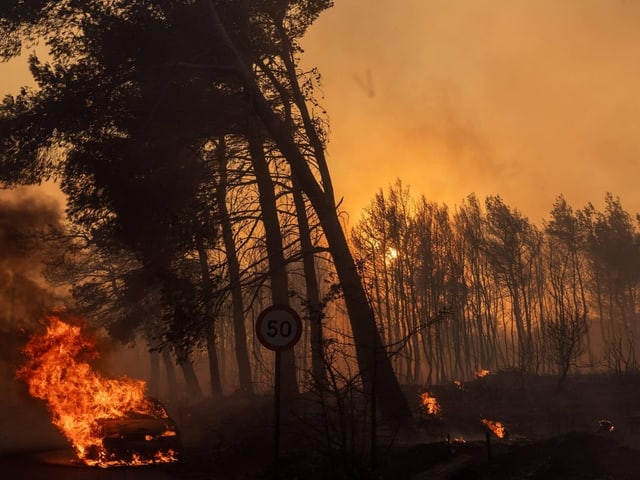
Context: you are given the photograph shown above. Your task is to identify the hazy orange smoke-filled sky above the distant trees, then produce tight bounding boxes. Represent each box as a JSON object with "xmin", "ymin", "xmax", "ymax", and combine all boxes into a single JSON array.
[{"xmin": 0, "ymin": 0, "xmax": 640, "ymax": 225}]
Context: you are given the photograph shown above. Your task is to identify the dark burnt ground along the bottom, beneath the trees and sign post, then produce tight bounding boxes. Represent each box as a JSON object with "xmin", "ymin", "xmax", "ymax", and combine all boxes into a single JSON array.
[{"xmin": 0, "ymin": 373, "xmax": 640, "ymax": 480}]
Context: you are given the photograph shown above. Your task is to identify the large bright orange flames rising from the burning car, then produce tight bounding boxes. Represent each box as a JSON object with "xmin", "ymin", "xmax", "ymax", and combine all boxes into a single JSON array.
[{"xmin": 18, "ymin": 315, "xmax": 176, "ymax": 467}]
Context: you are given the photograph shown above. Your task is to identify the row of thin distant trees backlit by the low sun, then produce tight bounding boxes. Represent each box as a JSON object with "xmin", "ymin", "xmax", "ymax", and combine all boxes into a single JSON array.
[{"xmin": 352, "ymin": 181, "xmax": 640, "ymax": 383}]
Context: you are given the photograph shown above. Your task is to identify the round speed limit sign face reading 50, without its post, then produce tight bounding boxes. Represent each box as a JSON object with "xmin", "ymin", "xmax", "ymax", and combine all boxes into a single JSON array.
[{"xmin": 256, "ymin": 305, "xmax": 302, "ymax": 351}]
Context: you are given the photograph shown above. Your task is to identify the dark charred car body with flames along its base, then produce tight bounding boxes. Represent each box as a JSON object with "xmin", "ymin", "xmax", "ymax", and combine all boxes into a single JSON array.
[{"xmin": 85, "ymin": 400, "xmax": 181, "ymax": 466}]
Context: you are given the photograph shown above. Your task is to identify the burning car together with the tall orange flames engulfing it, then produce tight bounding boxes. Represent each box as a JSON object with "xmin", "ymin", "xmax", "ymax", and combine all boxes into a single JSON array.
[{"xmin": 17, "ymin": 315, "xmax": 179, "ymax": 467}]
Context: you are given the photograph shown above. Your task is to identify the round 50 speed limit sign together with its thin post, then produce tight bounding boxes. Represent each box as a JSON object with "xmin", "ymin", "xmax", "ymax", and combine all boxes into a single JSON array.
[{"xmin": 256, "ymin": 305, "xmax": 302, "ymax": 480}]
